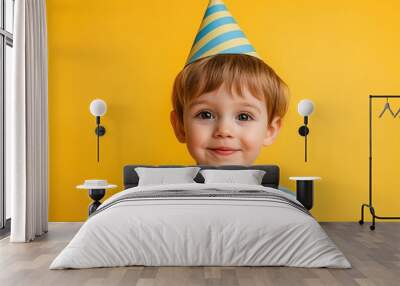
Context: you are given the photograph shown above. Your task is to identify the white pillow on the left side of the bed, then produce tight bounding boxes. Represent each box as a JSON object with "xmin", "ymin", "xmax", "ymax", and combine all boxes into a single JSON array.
[{"xmin": 135, "ymin": 167, "xmax": 200, "ymax": 186}]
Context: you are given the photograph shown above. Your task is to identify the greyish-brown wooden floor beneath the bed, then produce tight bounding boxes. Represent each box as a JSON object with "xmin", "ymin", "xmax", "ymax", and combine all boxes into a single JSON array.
[{"xmin": 0, "ymin": 222, "xmax": 400, "ymax": 286}]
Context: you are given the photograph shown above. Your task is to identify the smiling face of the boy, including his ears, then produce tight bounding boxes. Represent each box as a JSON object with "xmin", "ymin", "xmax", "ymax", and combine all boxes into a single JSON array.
[{"xmin": 171, "ymin": 85, "xmax": 280, "ymax": 165}]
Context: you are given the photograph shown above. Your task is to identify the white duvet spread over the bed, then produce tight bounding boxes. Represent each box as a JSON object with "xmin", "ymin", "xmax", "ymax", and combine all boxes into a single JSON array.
[{"xmin": 50, "ymin": 183, "xmax": 351, "ymax": 269}]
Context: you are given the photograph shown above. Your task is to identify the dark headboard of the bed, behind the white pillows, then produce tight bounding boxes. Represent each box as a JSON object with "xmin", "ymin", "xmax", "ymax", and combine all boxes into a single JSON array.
[{"xmin": 124, "ymin": 165, "xmax": 279, "ymax": 189}]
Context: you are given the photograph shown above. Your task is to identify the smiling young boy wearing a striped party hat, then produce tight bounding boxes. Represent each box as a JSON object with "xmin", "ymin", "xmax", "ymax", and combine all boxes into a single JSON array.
[{"xmin": 171, "ymin": 0, "xmax": 288, "ymax": 165}]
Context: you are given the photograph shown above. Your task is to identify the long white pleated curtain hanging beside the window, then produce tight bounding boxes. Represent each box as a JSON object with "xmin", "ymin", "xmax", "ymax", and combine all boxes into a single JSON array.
[{"xmin": 6, "ymin": 0, "xmax": 48, "ymax": 242}]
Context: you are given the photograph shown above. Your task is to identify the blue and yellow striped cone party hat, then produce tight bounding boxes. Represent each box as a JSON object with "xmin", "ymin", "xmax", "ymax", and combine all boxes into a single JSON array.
[{"xmin": 186, "ymin": 0, "xmax": 261, "ymax": 65}]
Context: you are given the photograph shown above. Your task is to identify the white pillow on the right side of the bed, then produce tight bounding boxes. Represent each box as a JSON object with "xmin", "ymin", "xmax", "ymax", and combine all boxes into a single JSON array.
[{"xmin": 200, "ymin": 169, "xmax": 265, "ymax": 185}]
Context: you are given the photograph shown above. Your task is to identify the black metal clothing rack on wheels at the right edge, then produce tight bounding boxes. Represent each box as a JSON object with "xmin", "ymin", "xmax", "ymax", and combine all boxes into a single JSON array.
[{"xmin": 359, "ymin": 95, "xmax": 400, "ymax": 230}]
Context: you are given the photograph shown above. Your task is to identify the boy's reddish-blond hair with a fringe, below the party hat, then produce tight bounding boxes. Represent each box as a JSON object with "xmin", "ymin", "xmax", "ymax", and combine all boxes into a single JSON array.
[{"xmin": 172, "ymin": 54, "xmax": 289, "ymax": 124}]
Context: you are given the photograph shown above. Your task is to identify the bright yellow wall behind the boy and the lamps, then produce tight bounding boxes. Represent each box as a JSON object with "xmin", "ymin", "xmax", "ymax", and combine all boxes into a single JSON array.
[{"xmin": 47, "ymin": 0, "xmax": 400, "ymax": 221}]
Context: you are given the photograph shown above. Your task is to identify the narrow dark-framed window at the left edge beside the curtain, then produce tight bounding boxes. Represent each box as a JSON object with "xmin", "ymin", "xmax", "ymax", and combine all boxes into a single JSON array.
[{"xmin": 0, "ymin": 0, "xmax": 14, "ymax": 233}]
